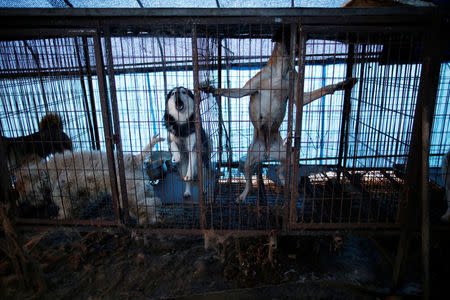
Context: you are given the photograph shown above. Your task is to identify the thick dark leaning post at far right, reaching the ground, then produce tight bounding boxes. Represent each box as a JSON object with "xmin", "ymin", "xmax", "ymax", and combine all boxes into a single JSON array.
[{"xmin": 393, "ymin": 16, "xmax": 442, "ymax": 299}]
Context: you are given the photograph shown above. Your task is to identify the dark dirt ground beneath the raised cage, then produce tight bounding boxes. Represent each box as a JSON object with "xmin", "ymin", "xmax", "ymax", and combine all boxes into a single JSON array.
[{"xmin": 0, "ymin": 225, "xmax": 449, "ymax": 300}]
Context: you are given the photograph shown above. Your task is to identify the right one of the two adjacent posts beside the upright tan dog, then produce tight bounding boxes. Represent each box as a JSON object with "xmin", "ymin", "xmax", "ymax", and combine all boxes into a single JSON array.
[{"xmin": 289, "ymin": 24, "xmax": 306, "ymax": 227}]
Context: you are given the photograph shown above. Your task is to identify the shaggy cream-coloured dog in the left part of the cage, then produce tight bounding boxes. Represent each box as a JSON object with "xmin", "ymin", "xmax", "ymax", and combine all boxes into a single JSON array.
[{"xmin": 15, "ymin": 136, "xmax": 164, "ymax": 225}]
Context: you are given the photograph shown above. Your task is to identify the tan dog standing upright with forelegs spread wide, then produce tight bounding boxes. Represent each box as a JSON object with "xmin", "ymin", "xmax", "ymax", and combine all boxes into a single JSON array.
[{"xmin": 202, "ymin": 32, "xmax": 356, "ymax": 202}]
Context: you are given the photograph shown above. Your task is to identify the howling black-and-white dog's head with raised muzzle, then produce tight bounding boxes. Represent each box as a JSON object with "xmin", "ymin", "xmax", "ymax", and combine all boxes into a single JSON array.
[{"xmin": 166, "ymin": 86, "xmax": 195, "ymax": 123}]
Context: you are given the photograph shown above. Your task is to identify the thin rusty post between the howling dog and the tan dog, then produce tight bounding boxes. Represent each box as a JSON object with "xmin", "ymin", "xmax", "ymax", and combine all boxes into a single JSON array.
[{"xmin": 192, "ymin": 24, "xmax": 206, "ymax": 230}]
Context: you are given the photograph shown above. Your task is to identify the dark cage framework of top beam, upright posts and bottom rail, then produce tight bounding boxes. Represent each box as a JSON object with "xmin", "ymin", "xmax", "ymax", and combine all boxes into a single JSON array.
[{"xmin": 0, "ymin": 7, "xmax": 450, "ymax": 293}]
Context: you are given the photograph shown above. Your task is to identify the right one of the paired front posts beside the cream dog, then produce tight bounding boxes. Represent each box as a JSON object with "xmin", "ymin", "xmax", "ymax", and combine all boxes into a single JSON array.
[{"xmin": 105, "ymin": 28, "xmax": 129, "ymax": 225}]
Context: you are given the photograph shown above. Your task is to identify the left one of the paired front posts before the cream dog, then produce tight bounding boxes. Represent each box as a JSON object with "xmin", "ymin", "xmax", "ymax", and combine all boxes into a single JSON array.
[{"xmin": 93, "ymin": 34, "xmax": 120, "ymax": 223}]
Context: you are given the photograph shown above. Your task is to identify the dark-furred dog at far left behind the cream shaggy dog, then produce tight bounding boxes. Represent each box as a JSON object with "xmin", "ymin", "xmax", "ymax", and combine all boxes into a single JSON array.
[{"xmin": 0, "ymin": 114, "xmax": 72, "ymax": 169}]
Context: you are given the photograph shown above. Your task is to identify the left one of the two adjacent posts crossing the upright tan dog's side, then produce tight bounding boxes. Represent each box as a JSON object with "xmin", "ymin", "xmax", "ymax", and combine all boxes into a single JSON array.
[{"xmin": 283, "ymin": 24, "xmax": 298, "ymax": 230}]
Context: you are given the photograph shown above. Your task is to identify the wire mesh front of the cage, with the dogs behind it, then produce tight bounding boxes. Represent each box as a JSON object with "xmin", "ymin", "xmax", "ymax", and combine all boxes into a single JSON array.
[{"xmin": 0, "ymin": 10, "xmax": 450, "ymax": 232}]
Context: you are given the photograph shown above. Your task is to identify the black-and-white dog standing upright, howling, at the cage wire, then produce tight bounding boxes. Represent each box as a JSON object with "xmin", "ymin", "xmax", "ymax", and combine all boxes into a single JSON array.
[{"xmin": 164, "ymin": 87, "xmax": 210, "ymax": 197}]
